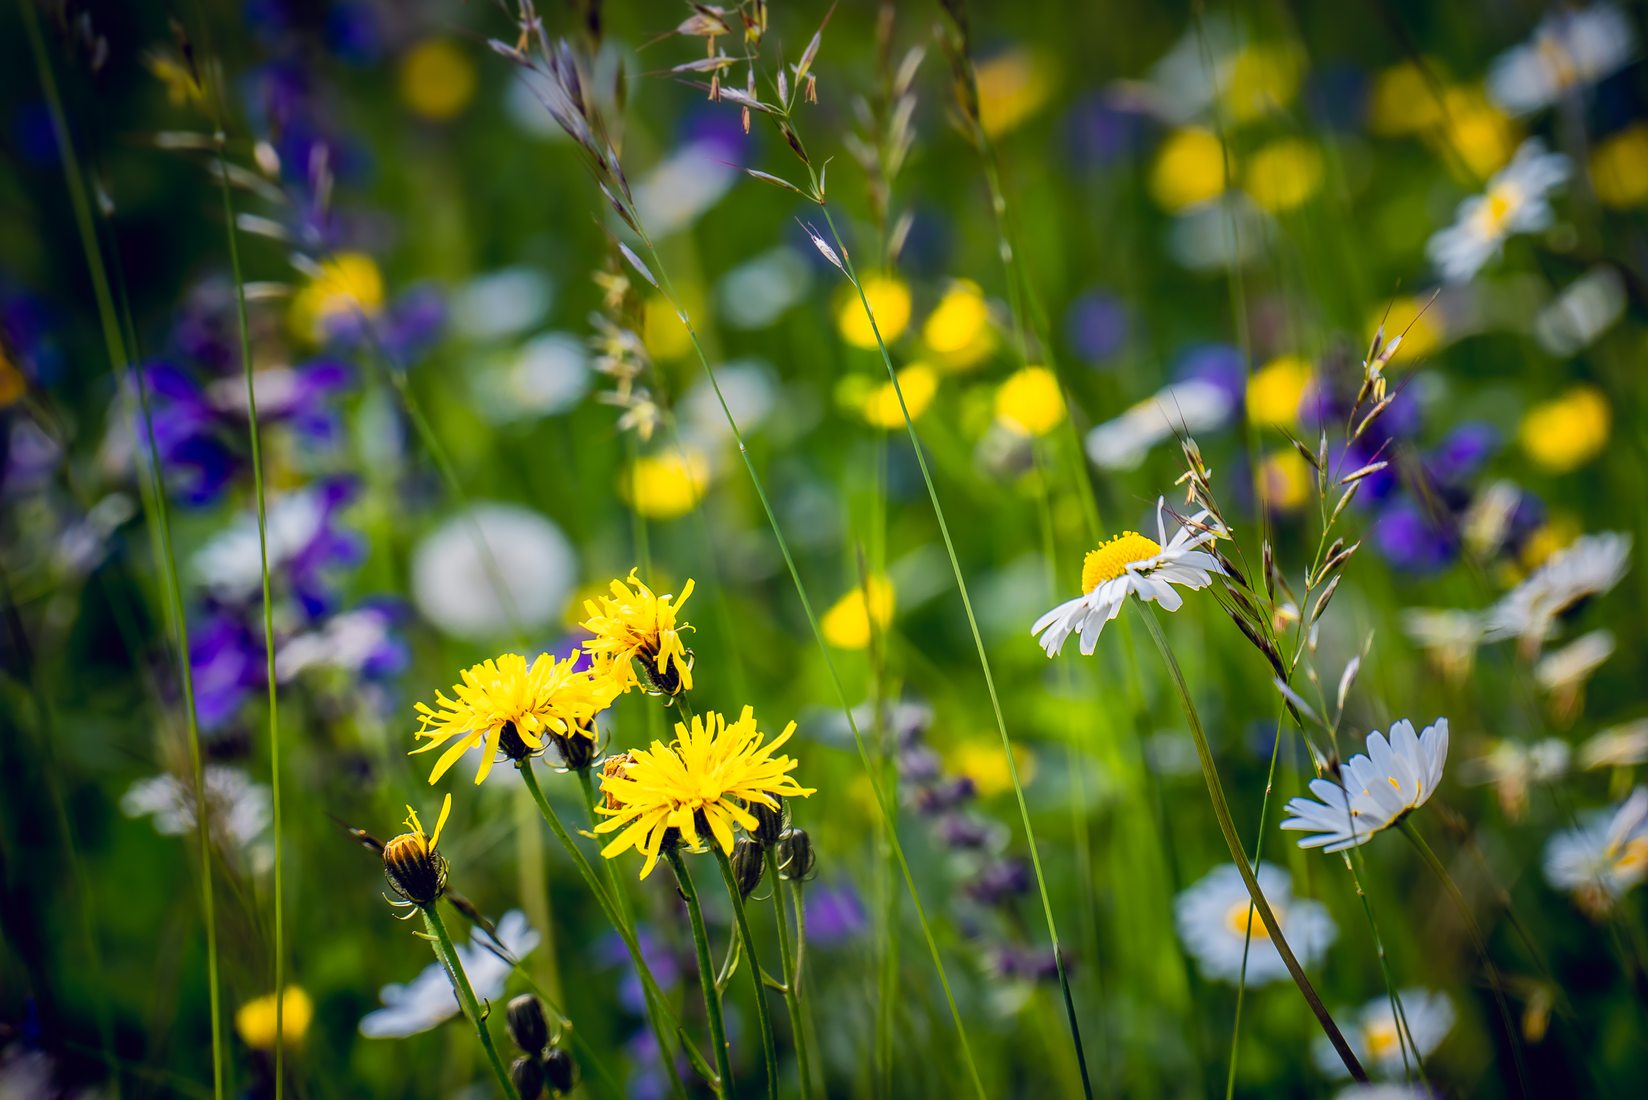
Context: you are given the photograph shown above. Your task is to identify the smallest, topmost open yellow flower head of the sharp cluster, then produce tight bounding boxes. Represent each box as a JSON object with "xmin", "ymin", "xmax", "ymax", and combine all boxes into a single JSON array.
[{"xmin": 578, "ymin": 569, "xmax": 692, "ymax": 696}]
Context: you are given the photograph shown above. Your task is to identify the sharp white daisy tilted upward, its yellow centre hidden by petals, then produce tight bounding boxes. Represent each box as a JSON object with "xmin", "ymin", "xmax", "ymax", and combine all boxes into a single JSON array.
[{"xmin": 1282, "ymin": 717, "xmax": 1447, "ymax": 851}]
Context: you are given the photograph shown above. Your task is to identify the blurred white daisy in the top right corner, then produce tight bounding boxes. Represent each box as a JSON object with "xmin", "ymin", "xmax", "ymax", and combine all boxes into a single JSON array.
[{"xmin": 1488, "ymin": 3, "xmax": 1636, "ymax": 114}]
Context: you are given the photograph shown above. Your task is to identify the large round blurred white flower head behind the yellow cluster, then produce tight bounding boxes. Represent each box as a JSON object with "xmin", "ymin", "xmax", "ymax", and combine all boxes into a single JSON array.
[{"xmin": 412, "ymin": 503, "xmax": 578, "ymax": 642}]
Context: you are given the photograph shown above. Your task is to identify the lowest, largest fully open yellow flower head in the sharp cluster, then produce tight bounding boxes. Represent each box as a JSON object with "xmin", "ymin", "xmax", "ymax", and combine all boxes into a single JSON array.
[{"xmin": 595, "ymin": 707, "xmax": 812, "ymax": 879}]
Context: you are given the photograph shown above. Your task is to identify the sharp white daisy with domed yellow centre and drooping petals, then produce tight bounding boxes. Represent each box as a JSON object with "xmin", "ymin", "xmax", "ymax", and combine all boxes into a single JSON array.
[{"xmin": 1030, "ymin": 496, "xmax": 1224, "ymax": 656}]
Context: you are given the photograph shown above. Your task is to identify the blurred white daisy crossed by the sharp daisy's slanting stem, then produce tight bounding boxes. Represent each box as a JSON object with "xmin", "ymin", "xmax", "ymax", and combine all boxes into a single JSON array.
[{"xmin": 1173, "ymin": 863, "xmax": 1338, "ymax": 985}]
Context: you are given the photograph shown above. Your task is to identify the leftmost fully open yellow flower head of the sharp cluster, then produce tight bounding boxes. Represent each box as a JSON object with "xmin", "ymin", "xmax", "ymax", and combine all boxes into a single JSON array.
[{"xmin": 412, "ymin": 653, "xmax": 623, "ymax": 783}]
